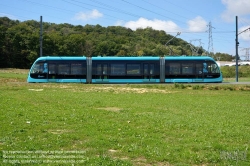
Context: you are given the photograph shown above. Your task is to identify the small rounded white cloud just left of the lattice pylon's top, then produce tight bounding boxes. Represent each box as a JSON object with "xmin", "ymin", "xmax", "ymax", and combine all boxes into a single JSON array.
[{"xmin": 187, "ymin": 16, "xmax": 208, "ymax": 32}]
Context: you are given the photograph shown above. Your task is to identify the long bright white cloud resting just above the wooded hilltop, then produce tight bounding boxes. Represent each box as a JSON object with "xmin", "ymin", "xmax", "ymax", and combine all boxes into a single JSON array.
[{"xmin": 122, "ymin": 18, "xmax": 180, "ymax": 32}]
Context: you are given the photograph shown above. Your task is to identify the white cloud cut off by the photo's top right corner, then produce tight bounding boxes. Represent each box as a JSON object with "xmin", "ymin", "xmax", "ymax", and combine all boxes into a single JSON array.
[{"xmin": 221, "ymin": 0, "xmax": 250, "ymax": 22}]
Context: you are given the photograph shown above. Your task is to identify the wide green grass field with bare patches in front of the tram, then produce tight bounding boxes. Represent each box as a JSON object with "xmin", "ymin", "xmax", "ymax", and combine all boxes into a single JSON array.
[{"xmin": 0, "ymin": 69, "xmax": 250, "ymax": 166}]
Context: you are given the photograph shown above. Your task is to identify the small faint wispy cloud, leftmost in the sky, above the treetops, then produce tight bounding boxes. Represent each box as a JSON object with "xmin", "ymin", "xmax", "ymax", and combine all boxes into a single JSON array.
[{"xmin": 74, "ymin": 9, "xmax": 103, "ymax": 21}]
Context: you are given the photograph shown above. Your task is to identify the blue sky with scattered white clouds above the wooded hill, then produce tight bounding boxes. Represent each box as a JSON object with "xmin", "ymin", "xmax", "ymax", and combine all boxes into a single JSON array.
[{"xmin": 0, "ymin": 0, "xmax": 250, "ymax": 60}]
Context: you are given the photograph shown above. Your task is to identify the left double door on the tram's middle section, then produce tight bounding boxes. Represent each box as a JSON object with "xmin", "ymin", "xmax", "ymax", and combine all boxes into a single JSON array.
[{"xmin": 96, "ymin": 63, "xmax": 109, "ymax": 82}]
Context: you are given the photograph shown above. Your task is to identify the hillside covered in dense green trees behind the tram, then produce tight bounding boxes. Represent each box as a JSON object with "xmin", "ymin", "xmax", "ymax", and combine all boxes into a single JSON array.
[{"xmin": 0, "ymin": 17, "xmax": 232, "ymax": 68}]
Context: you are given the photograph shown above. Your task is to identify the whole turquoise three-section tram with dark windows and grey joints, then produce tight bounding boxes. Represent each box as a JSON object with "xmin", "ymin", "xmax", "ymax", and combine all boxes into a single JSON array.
[{"xmin": 27, "ymin": 56, "xmax": 222, "ymax": 83}]
